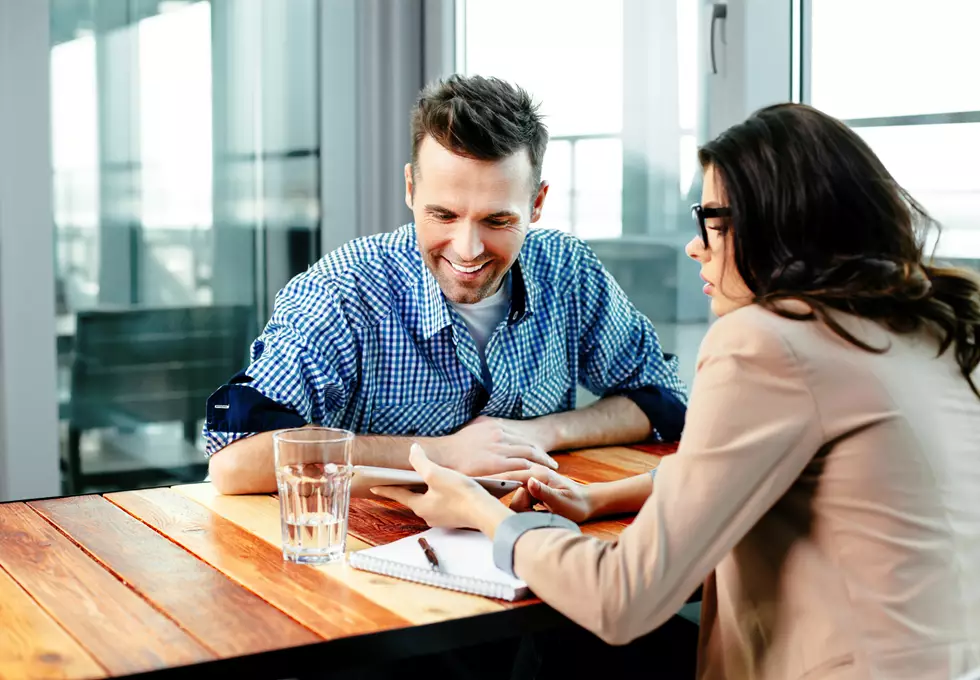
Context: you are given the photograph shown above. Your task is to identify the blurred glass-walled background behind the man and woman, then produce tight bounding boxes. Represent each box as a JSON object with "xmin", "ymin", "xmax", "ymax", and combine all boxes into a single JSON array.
[{"xmin": 0, "ymin": 0, "xmax": 980, "ymax": 499}]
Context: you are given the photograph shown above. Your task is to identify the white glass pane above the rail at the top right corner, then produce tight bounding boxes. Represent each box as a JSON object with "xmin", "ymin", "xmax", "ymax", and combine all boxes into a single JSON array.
[{"xmin": 810, "ymin": 0, "xmax": 980, "ymax": 118}]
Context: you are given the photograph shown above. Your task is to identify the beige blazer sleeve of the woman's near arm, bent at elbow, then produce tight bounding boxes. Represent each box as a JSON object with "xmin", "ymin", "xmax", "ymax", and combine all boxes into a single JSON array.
[{"xmin": 514, "ymin": 308, "xmax": 823, "ymax": 644}]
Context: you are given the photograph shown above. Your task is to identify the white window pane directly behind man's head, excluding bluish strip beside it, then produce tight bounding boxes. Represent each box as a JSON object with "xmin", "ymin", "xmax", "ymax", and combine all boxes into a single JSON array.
[{"xmin": 457, "ymin": 0, "xmax": 623, "ymax": 237}]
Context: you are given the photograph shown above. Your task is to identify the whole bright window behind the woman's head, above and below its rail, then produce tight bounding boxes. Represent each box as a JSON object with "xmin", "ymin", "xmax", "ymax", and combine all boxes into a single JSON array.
[{"xmin": 807, "ymin": 0, "xmax": 980, "ymax": 260}]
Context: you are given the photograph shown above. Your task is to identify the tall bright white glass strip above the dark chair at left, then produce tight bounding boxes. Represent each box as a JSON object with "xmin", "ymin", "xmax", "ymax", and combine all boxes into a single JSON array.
[{"xmin": 137, "ymin": 2, "xmax": 213, "ymax": 305}]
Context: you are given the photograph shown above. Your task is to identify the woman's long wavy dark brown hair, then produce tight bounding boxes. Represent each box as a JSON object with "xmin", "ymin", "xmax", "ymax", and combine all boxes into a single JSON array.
[{"xmin": 699, "ymin": 104, "xmax": 980, "ymax": 398}]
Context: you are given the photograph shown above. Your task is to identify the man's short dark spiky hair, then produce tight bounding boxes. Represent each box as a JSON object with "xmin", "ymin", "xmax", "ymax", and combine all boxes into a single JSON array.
[{"xmin": 412, "ymin": 74, "xmax": 548, "ymax": 189}]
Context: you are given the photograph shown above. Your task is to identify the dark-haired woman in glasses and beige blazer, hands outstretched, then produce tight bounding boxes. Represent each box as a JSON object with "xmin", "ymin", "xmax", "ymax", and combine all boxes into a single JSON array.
[{"xmin": 379, "ymin": 105, "xmax": 980, "ymax": 680}]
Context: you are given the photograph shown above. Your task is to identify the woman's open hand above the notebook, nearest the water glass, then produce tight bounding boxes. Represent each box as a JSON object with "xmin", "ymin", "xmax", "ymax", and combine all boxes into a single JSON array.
[{"xmin": 371, "ymin": 444, "xmax": 512, "ymax": 538}]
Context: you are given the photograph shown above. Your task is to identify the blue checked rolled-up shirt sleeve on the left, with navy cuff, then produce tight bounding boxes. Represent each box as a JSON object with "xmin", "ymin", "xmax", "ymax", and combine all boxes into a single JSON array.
[{"xmin": 204, "ymin": 270, "xmax": 358, "ymax": 456}]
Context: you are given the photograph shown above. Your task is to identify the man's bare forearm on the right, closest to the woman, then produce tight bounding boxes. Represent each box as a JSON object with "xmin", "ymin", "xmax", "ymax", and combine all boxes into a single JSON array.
[{"xmin": 534, "ymin": 396, "xmax": 651, "ymax": 451}]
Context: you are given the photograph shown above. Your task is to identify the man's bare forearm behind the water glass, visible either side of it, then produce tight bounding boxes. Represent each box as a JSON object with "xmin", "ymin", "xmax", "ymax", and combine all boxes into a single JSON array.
[{"xmin": 209, "ymin": 432, "xmax": 432, "ymax": 494}]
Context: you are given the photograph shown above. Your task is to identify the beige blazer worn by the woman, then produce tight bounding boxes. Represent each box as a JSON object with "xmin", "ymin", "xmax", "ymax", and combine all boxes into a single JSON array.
[{"xmin": 514, "ymin": 306, "xmax": 980, "ymax": 680}]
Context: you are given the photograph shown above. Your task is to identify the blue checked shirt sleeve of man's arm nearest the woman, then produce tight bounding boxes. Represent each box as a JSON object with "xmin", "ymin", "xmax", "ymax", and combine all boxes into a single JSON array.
[{"xmin": 579, "ymin": 247, "xmax": 687, "ymax": 441}]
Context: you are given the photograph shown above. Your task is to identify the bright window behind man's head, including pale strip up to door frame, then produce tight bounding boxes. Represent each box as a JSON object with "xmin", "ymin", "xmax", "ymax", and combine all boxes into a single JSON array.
[{"xmin": 457, "ymin": 0, "xmax": 701, "ymax": 239}]
